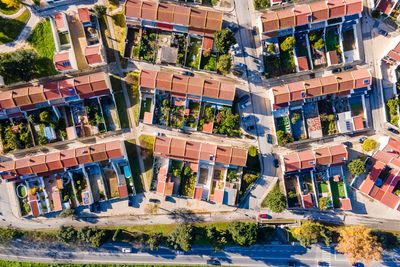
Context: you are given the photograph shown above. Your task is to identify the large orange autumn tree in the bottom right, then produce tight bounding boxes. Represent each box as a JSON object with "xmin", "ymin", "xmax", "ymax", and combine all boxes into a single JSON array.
[{"xmin": 336, "ymin": 225, "xmax": 382, "ymax": 264}]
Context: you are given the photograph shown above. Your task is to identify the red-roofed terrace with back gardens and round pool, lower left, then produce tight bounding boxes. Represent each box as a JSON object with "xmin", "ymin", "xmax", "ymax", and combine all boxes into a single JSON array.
[{"xmin": 0, "ymin": 140, "xmax": 134, "ymax": 217}]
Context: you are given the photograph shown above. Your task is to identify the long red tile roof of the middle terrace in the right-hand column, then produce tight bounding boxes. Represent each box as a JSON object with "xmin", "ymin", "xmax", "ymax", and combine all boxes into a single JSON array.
[{"xmin": 271, "ymin": 69, "xmax": 372, "ymax": 105}]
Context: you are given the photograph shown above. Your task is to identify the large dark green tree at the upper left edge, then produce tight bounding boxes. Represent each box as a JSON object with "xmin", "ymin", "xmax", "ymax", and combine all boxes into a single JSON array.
[{"xmin": 0, "ymin": 49, "xmax": 39, "ymax": 83}]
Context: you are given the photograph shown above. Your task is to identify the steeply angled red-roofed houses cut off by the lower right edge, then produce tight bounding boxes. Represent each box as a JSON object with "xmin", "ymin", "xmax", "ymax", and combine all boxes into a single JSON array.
[{"xmin": 357, "ymin": 137, "xmax": 400, "ymax": 211}]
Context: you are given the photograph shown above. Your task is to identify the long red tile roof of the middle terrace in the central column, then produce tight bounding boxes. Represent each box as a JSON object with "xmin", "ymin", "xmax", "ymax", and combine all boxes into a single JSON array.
[{"xmin": 139, "ymin": 70, "xmax": 236, "ymax": 101}]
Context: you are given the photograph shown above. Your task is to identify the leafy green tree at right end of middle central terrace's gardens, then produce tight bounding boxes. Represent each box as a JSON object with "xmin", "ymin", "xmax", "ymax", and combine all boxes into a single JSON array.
[{"xmin": 213, "ymin": 107, "xmax": 241, "ymax": 137}]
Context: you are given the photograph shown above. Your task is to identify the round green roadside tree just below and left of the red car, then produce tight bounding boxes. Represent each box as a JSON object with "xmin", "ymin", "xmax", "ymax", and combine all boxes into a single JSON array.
[{"xmin": 228, "ymin": 221, "xmax": 257, "ymax": 246}]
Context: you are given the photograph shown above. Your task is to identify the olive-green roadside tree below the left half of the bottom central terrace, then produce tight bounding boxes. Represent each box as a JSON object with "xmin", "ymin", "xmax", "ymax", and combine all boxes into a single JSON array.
[{"xmin": 167, "ymin": 223, "xmax": 193, "ymax": 251}]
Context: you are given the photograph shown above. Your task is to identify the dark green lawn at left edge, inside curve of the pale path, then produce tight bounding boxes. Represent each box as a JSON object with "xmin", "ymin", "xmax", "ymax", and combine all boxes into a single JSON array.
[{"xmin": 0, "ymin": 10, "xmax": 31, "ymax": 44}]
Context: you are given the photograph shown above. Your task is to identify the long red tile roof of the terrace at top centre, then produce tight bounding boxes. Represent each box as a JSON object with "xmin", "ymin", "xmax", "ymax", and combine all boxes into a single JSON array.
[{"xmin": 125, "ymin": 0, "xmax": 223, "ymax": 34}]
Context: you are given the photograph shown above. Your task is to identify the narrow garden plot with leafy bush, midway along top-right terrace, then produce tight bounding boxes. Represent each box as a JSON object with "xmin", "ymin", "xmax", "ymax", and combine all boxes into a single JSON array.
[{"xmin": 308, "ymin": 29, "xmax": 326, "ymax": 69}]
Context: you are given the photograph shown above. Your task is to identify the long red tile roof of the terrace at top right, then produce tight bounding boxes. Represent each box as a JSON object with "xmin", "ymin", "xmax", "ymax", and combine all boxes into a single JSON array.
[{"xmin": 260, "ymin": 0, "xmax": 363, "ymax": 33}]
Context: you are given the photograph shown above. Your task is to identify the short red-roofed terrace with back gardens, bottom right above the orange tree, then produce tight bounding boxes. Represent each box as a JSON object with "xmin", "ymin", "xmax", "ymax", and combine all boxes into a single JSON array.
[{"xmin": 282, "ymin": 144, "xmax": 351, "ymax": 210}]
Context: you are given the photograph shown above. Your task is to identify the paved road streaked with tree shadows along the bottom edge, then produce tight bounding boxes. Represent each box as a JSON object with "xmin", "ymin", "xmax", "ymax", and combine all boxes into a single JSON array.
[{"xmin": 0, "ymin": 245, "xmax": 396, "ymax": 267}]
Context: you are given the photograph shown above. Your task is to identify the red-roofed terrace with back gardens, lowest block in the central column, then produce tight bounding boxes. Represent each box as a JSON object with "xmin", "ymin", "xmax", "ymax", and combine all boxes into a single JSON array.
[{"xmin": 152, "ymin": 137, "xmax": 247, "ymax": 205}]
